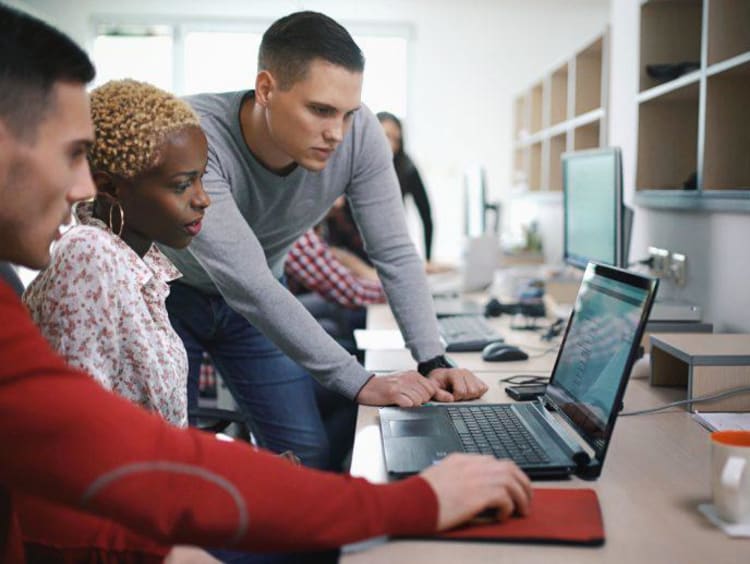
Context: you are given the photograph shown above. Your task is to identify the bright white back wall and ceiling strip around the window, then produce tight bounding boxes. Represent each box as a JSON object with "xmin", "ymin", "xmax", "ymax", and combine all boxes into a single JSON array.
[{"xmin": 25, "ymin": 0, "xmax": 609, "ymax": 260}]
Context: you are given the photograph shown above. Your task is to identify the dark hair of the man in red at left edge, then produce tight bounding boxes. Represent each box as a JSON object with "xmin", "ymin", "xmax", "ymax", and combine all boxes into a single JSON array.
[{"xmin": 0, "ymin": 4, "xmax": 95, "ymax": 139}]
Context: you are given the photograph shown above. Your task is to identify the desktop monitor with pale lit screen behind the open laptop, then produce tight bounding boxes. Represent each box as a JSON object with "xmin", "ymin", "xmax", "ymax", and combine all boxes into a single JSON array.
[{"xmin": 562, "ymin": 147, "xmax": 632, "ymax": 268}]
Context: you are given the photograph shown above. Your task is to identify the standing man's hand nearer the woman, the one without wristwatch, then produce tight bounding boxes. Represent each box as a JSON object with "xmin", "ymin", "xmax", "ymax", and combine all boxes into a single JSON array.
[{"xmin": 356, "ymin": 370, "xmax": 453, "ymax": 407}]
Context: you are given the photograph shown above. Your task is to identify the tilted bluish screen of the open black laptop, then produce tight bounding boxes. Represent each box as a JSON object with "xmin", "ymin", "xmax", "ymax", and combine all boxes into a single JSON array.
[{"xmin": 546, "ymin": 263, "xmax": 656, "ymax": 456}]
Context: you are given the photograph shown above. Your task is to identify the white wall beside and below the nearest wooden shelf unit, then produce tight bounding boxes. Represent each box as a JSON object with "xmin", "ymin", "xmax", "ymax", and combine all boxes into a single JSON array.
[{"xmin": 610, "ymin": 0, "xmax": 750, "ymax": 332}]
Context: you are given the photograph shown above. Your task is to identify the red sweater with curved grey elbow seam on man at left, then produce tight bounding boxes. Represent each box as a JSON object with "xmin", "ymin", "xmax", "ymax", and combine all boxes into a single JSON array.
[{"xmin": 0, "ymin": 283, "xmax": 437, "ymax": 562}]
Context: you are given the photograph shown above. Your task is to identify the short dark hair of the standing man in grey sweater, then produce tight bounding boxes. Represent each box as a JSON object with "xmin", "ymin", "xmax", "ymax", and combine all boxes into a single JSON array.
[{"xmin": 258, "ymin": 12, "xmax": 365, "ymax": 89}]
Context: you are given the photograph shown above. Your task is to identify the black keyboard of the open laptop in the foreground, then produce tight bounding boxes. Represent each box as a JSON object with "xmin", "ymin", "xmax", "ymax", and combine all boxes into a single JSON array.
[{"xmin": 445, "ymin": 405, "xmax": 549, "ymax": 465}]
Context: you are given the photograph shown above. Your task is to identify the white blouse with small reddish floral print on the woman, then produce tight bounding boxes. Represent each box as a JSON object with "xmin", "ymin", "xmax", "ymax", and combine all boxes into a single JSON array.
[{"xmin": 24, "ymin": 203, "xmax": 188, "ymax": 427}]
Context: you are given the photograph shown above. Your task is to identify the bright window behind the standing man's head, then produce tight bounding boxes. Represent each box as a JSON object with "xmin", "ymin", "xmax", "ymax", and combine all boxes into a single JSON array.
[{"xmin": 92, "ymin": 21, "xmax": 418, "ymax": 118}]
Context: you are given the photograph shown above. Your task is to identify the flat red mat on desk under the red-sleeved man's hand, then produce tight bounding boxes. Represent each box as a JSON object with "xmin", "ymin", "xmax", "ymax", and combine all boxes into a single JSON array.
[{"xmin": 430, "ymin": 488, "xmax": 604, "ymax": 546}]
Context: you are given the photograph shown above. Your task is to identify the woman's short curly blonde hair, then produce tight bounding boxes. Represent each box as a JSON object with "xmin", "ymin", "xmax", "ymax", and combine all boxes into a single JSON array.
[{"xmin": 89, "ymin": 79, "xmax": 200, "ymax": 179}]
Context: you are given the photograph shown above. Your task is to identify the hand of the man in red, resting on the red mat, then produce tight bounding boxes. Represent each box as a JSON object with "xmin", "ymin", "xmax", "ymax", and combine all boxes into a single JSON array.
[{"xmin": 421, "ymin": 454, "xmax": 532, "ymax": 531}]
